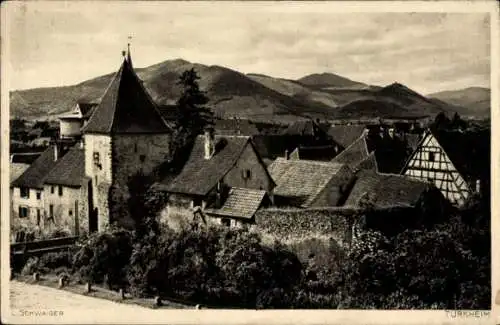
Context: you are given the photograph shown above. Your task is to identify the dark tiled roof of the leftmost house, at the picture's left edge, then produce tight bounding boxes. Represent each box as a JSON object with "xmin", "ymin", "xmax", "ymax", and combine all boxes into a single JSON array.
[{"xmin": 12, "ymin": 146, "xmax": 55, "ymax": 189}]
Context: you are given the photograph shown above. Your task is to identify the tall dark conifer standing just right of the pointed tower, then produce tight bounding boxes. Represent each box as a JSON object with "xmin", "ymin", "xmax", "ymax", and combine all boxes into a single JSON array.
[{"xmin": 175, "ymin": 68, "xmax": 213, "ymax": 148}]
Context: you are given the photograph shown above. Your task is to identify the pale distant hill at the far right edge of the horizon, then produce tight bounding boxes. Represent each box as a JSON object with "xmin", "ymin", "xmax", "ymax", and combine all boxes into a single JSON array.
[{"xmin": 427, "ymin": 87, "xmax": 491, "ymax": 117}]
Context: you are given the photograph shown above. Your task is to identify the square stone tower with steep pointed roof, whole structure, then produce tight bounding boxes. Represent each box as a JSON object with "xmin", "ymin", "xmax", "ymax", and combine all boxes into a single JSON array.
[{"xmin": 82, "ymin": 50, "xmax": 172, "ymax": 231}]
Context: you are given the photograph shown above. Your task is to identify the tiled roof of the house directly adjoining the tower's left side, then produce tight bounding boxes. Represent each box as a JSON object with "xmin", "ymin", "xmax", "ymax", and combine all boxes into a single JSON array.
[{"xmin": 45, "ymin": 144, "xmax": 85, "ymax": 187}]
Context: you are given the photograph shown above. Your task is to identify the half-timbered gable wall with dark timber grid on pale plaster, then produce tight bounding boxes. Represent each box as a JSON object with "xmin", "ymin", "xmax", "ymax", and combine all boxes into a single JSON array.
[{"xmin": 403, "ymin": 134, "xmax": 470, "ymax": 206}]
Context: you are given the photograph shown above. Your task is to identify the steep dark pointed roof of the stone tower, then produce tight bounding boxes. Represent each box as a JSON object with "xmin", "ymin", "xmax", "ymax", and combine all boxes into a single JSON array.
[{"xmin": 83, "ymin": 52, "xmax": 171, "ymax": 134}]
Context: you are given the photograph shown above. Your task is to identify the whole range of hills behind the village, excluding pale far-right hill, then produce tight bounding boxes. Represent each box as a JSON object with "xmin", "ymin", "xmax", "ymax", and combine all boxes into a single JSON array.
[{"xmin": 10, "ymin": 59, "xmax": 484, "ymax": 123}]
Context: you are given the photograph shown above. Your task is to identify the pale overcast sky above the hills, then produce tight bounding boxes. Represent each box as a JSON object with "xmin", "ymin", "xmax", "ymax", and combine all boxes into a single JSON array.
[{"xmin": 8, "ymin": 1, "xmax": 490, "ymax": 94}]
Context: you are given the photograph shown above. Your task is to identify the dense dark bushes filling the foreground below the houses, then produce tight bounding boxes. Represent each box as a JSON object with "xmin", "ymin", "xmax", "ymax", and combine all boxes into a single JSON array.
[{"xmin": 18, "ymin": 195, "xmax": 491, "ymax": 309}]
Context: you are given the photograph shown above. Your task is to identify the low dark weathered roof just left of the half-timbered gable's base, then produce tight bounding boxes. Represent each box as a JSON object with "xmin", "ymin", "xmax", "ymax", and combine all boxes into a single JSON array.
[{"xmin": 345, "ymin": 170, "xmax": 432, "ymax": 208}]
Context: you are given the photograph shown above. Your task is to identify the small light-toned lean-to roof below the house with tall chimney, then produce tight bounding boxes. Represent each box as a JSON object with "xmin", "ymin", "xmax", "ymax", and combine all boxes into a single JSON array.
[{"xmin": 205, "ymin": 188, "xmax": 266, "ymax": 219}]
